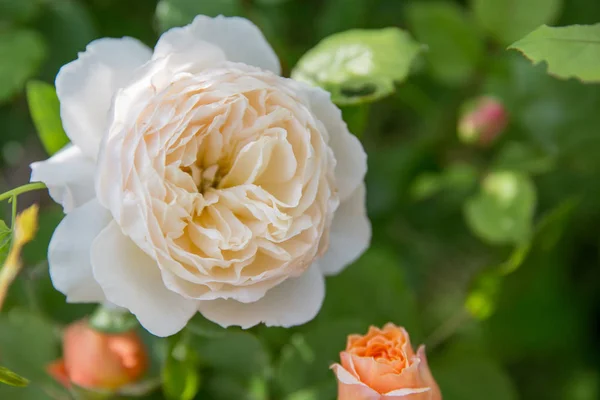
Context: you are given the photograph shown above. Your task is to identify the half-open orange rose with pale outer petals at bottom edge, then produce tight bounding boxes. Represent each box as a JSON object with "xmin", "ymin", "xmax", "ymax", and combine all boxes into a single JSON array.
[{"xmin": 331, "ymin": 324, "xmax": 442, "ymax": 400}]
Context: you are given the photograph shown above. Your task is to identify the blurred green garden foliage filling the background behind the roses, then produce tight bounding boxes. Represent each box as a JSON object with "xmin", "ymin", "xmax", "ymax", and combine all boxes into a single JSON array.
[{"xmin": 0, "ymin": 0, "xmax": 600, "ymax": 400}]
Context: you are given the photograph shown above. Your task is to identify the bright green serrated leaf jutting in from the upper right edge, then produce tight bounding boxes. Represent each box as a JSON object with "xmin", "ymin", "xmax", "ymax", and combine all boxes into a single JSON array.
[{"xmin": 509, "ymin": 24, "xmax": 600, "ymax": 83}]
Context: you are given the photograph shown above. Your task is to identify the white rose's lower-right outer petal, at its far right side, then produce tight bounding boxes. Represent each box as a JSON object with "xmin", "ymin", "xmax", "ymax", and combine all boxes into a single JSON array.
[{"xmin": 319, "ymin": 183, "xmax": 371, "ymax": 275}]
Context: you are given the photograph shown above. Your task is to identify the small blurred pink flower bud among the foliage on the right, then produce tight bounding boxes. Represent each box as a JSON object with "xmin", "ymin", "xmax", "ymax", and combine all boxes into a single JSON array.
[{"xmin": 458, "ymin": 96, "xmax": 508, "ymax": 146}]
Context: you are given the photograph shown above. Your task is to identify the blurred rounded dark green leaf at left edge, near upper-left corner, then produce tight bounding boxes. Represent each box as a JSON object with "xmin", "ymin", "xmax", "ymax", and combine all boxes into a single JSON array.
[{"xmin": 0, "ymin": 29, "xmax": 46, "ymax": 102}]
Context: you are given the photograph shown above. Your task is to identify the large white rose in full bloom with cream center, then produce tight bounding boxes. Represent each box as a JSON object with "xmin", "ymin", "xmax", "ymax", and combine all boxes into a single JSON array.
[{"xmin": 31, "ymin": 16, "xmax": 371, "ymax": 336}]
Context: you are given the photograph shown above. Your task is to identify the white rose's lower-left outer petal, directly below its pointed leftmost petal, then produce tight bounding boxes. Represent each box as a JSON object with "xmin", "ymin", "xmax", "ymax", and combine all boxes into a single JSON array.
[{"xmin": 48, "ymin": 200, "xmax": 112, "ymax": 303}]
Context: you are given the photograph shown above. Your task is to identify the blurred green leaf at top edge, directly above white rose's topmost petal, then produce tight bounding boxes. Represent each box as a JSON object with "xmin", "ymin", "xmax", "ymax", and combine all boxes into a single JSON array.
[{"xmin": 156, "ymin": 0, "xmax": 244, "ymax": 32}]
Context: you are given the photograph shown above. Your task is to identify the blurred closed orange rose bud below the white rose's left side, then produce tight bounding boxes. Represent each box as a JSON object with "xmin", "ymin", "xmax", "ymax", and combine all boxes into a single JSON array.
[{"xmin": 47, "ymin": 321, "xmax": 148, "ymax": 391}]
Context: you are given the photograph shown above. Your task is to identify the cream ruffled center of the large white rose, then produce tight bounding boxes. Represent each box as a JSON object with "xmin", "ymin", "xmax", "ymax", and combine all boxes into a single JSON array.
[{"xmin": 120, "ymin": 64, "xmax": 338, "ymax": 301}]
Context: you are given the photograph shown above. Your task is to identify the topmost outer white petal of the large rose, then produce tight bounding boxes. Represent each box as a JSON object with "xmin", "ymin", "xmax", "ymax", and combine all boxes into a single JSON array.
[{"xmin": 154, "ymin": 15, "xmax": 281, "ymax": 75}]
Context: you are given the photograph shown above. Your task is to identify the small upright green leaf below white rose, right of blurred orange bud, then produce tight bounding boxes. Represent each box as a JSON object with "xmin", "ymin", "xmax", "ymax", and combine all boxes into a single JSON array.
[{"xmin": 162, "ymin": 337, "xmax": 200, "ymax": 400}]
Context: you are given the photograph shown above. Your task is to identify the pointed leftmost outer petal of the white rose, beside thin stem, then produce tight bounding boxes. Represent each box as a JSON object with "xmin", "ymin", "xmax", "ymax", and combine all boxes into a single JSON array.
[{"xmin": 31, "ymin": 145, "xmax": 95, "ymax": 213}]
